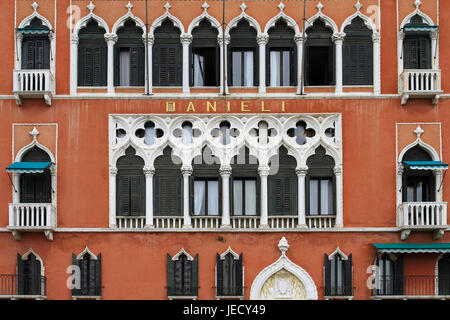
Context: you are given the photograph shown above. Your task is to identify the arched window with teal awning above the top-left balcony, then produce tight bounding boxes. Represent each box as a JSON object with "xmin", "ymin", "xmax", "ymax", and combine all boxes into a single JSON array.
[{"xmin": 19, "ymin": 18, "xmax": 50, "ymax": 69}]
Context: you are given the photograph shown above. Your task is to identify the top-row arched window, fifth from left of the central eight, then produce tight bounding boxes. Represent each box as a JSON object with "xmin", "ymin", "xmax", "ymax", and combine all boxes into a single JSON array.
[{"xmin": 228, "ymin": 19, "xmax": 259, "ymax": 87}]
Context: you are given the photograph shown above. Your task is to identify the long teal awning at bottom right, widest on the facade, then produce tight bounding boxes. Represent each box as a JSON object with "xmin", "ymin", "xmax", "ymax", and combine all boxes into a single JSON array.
[{"xmin": 372, "ymin": 242, "xmax": 450, "ymax": 253}]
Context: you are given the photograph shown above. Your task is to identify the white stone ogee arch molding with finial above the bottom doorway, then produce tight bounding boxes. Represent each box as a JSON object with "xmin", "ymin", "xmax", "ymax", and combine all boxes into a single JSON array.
[{"xmin": 250, "ymin": 237, "xmax": 318, "ymax": 300}]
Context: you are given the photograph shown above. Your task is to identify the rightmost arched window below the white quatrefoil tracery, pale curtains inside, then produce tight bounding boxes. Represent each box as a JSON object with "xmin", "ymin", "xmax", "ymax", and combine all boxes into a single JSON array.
[{"xmin": 306, "ymin": 146, "xmax": 336, "ymax": 216}]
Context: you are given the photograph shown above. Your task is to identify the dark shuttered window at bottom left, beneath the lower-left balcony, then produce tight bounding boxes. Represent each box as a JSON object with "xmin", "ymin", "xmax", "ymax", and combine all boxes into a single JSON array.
[{"xmin": 17, "ymin": 253, "xmax": 45, "ymax": 296}]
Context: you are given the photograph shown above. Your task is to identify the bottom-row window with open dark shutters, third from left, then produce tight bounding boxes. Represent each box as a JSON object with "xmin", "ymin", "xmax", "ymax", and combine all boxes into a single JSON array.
[{"xmin": 167, "ymin": 253, "xmax": 198, "ymax": 297}]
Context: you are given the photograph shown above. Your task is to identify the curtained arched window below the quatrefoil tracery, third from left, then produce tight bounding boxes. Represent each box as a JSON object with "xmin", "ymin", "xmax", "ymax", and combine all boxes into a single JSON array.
[{"xmin": 189, "ymin": 147, "xmax": 222, "ymax": 216}]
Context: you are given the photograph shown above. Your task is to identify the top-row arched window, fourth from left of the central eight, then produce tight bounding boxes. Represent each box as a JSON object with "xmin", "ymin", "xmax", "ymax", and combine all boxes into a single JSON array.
[{"xmin": 190, "ymin": 19, "xmax": 220, "ymax": 87}]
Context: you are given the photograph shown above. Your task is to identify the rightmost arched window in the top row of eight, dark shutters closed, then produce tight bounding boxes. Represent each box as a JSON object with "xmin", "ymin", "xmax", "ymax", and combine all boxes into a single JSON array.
[{"xmin": 343, "ymin": 17, "xmax": 373, "ymax": 85}]
